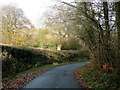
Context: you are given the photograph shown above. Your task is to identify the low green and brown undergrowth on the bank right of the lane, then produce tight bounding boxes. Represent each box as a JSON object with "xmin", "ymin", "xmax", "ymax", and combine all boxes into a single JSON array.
[{"xmin": 77, "ymin": 64, "xmax": 120, "ymax": 90}]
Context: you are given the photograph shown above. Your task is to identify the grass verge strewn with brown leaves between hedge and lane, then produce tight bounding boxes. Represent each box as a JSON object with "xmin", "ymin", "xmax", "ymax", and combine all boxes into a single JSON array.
[{"xmin": 3, "ymin": 62, "xmax": 83, "ymax": 88}]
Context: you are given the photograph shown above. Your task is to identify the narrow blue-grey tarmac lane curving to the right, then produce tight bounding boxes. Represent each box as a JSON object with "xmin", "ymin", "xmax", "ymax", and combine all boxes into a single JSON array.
[{"xmin": 23, "ymin": 62, "xmax": 90, "ymax": 88}]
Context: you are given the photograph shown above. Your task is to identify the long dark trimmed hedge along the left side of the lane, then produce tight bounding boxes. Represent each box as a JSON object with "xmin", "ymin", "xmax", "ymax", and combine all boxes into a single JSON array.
[{"xmin": 1, "ymin": 45, "xmax": 89, "ymax": 78}]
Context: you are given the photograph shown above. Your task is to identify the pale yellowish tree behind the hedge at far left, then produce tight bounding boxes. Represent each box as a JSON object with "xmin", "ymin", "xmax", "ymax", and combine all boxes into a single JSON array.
[{"xmin": 0, "ymin": 5, "xmax": 36, "ymax": 46}]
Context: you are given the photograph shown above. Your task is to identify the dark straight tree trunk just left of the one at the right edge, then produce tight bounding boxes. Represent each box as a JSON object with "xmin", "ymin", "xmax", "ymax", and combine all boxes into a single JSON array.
[{"xmin": 102, "ymin": 2, "xmax": 113, "ymax": 65}]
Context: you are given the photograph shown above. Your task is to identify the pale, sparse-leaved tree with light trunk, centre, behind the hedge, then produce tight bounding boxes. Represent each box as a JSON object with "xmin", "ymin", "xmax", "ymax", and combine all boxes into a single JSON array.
[{"xmin": 44, "ymin": 4, "xmax": 79, "ymax": 50}]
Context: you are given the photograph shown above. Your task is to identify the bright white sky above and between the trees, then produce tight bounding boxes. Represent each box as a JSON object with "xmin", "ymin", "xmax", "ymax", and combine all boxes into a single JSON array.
[{"xmin": 0, "ymin": 0, "xmax": 71, "ymax": 27}]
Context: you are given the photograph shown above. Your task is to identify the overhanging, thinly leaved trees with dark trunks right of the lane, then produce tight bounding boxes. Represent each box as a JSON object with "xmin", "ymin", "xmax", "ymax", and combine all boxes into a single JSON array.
[{"xmin": 43, "ymin": 0, "xmax": 120, "ymax": 67}]
